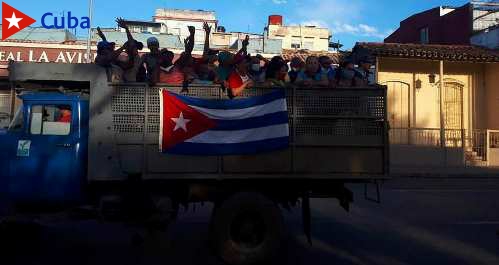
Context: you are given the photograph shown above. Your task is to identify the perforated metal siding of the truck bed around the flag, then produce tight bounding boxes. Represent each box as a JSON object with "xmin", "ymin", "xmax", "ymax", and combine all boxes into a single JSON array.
[{"xmin": 110, "ymin": 83, "xmax": 386, "ymax": 144}]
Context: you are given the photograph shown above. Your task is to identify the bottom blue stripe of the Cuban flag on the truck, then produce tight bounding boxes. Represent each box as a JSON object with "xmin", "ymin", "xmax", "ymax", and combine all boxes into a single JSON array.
[{"xmin": 164, "ymin": 137, "xmax": 289, "ymax": 155}]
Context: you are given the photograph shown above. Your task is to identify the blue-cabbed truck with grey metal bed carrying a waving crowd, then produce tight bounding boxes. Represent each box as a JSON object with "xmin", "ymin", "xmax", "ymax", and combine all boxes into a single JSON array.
[{"xmin": 0, "ymin": 63, "xmax": 388, "ymax": 264}]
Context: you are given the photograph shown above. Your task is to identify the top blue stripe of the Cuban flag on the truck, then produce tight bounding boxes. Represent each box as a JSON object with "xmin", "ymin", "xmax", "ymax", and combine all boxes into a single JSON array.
[{"xmin": 169, "ymin": 89, "xmax": 286, "ymax": 109}]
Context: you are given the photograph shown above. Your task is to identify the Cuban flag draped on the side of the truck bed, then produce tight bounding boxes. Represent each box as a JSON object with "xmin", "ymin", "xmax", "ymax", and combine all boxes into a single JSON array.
[{"xmin": 159, "ymin": 89, "xmax": 289, "ymax": 155}]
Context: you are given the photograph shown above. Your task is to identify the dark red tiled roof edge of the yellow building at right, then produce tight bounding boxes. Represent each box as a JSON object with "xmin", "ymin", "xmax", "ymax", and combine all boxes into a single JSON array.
[{"xmin": 353, "ymin": 42, "xmax": 499, "ymax": 63}]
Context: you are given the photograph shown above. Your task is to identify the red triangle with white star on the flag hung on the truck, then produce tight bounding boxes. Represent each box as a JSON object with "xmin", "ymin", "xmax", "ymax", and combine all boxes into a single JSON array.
[{"xmin": 160, "ymin": 90, "xmax": 216, "ymax": 150}]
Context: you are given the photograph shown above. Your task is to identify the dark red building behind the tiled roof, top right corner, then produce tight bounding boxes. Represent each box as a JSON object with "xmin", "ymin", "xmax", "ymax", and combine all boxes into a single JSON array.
[{"xmin": 384, "ymin": 1, "xmax": 499, "ymax": 48}]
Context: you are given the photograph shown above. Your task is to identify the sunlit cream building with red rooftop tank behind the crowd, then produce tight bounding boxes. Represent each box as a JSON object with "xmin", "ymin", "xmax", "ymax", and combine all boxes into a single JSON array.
[{"xmin": 265, "ymin": 15, "xmax": 331, "ymax": 52}]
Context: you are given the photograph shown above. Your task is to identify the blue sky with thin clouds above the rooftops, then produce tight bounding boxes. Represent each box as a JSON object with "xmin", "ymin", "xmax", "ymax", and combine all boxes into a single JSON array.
[{"xmin": 5, "ymin": 0, "xmax": 468, "ymax": 49}]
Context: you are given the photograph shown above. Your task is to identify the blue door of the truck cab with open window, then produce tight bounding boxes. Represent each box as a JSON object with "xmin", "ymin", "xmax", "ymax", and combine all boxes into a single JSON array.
[{"xmin": 9, "ymin": 100, "xmax": 80, "ymax": 203}]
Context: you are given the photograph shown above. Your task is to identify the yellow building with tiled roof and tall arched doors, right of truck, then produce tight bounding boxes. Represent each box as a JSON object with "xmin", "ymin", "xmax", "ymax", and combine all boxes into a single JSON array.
[{"xmin": 354, "ymin": 43, "xmax": 499, "ymax": 174}]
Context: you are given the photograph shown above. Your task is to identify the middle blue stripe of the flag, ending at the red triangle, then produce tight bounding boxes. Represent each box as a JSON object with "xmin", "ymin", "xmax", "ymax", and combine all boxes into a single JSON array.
[{"xmin": 210, "ymin": 111, "xmax": 289, "ymax": 131}]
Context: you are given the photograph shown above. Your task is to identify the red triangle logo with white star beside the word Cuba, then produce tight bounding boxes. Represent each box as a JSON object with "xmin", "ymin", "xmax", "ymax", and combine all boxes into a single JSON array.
[{"xmin": 2, "ymin": 2, "xmax": 36, "ymax": 40}]
